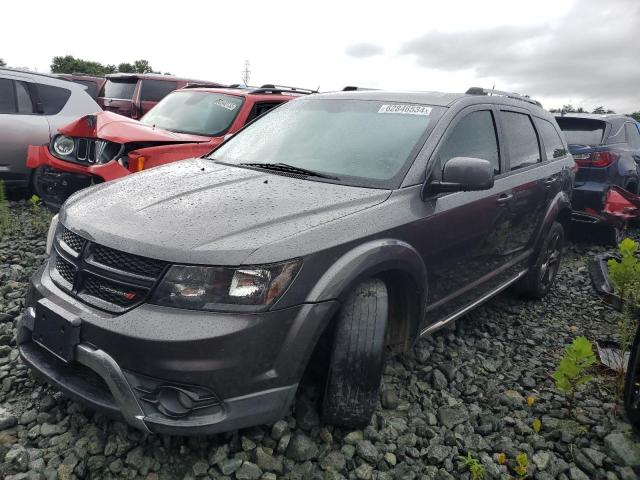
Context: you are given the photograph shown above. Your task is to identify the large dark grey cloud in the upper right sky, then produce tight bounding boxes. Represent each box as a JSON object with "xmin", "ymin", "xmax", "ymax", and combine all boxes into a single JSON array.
[{"xmin": 399, "ymin": 0, "xmax": 640, "ymax": 111}]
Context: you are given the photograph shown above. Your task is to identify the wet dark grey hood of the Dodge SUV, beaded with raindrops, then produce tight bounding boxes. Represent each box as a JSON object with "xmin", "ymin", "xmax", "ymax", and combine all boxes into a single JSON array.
[{"xmin": 60, "ymin": 159, "xmax": 390, "ymax": 265}]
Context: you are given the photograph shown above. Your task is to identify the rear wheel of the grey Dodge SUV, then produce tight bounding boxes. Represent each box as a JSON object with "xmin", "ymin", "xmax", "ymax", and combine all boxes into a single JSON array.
[{"xmin": 518, "ymin": 222, "xmax": 564, "ymax": 300}]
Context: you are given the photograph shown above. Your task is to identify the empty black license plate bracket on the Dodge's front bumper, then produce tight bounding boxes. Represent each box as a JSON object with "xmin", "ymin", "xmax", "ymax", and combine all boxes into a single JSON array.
[{"xmin": 32, "ymin": 299, "xmax": 80, "ymax": 363}]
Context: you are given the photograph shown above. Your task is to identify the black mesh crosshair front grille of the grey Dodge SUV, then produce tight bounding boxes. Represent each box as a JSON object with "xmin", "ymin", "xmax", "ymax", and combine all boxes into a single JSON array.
[{"xmin": 52, "ymin": 227, "xmax": 167, "ymax": 313}]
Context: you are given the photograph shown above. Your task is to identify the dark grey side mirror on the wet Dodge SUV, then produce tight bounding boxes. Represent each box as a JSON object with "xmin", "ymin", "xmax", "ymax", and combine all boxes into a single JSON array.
[{"xmin": 422, "ymin": 157, "xmax": 493, "ymax": 199}]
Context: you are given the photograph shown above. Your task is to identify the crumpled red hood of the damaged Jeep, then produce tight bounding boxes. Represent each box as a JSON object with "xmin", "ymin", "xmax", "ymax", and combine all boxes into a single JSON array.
[{"xmin": 58, "ymin": 112, "xmax": 211, "ymax": 143}]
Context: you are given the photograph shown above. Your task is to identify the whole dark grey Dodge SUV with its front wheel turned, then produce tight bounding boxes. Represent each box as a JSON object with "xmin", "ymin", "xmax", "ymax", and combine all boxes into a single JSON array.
[{"xmin": 17, "ymin": 88, "xmax": 574, "ymax": 435}]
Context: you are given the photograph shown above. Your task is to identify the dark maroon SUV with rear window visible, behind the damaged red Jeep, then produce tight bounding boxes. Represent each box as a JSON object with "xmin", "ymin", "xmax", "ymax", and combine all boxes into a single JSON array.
[{"xmin": 98, "ymin": 73, "xmax": 223, "ymax": 119}]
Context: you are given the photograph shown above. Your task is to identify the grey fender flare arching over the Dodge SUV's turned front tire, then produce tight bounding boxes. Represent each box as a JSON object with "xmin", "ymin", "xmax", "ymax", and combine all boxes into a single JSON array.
[{"xmin": 306, "ymin": 238, "xmax": 428, "ymax": 341}]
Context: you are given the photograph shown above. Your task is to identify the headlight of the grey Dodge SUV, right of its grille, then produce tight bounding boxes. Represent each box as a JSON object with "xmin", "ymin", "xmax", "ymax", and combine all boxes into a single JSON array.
[{"xmin": 151, "ymin": 260, "xmax": 300, "ymax": 311}]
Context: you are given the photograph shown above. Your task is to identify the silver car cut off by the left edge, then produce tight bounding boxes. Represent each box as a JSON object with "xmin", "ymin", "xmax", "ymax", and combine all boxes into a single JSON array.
[{"xmin": 0, "ymin": 68, "xmax": 101, "ymax": 187}]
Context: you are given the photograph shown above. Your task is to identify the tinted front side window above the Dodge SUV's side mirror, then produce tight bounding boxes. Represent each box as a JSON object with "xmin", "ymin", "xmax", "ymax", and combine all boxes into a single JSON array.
[{"xmin": 438, "ymin": 110, "xmax": 500, "ymax": 173}]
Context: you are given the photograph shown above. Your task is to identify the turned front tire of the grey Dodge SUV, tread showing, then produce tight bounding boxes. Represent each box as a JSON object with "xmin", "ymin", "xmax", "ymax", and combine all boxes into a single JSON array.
[{"xmin": 322, "ymin": 278, "xmax": 389, "ymax": 428}]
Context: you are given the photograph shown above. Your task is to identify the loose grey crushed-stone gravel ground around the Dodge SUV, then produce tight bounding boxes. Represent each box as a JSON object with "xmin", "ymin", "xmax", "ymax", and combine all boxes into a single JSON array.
[{"xmin": 0, "ymin": 202, "xmax": 640, "ymax": 480}]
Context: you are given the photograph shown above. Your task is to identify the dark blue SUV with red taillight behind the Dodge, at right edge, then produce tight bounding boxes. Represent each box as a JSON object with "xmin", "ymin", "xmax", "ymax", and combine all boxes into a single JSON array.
[{"xmin": 556, "ymin": 114, "xmax": 640, "ymax": 242}]
